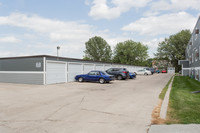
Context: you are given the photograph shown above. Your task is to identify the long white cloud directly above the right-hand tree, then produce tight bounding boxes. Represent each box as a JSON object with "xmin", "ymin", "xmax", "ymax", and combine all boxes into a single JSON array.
[{"xmin": 122, "ymin": 12, "xmax": 197, "ymax": 36}]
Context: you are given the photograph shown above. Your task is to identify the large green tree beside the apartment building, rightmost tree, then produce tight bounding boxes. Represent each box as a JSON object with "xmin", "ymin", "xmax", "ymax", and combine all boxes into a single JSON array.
[{"xmin": 155, "ymin": 30, "xmax": 191, "ymax": 71}]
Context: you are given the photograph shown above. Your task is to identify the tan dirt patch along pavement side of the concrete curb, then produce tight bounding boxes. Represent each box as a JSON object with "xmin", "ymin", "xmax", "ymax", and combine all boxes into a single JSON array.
[{"xmin": 151, "ymin": 99, "xmax": 165, "ymax": 124}]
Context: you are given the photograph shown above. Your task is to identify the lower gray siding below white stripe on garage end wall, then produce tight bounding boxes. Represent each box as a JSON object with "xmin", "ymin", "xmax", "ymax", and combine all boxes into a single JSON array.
[{"xmin": 0, "ymin": 73, "xmax": 44, "ymax": 85}]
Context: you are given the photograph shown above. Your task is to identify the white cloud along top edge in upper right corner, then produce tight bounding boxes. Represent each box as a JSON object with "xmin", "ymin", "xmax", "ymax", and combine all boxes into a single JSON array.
[{"xmin": 151, "ymin": 0, "xmax": 200, "ymax": 11}]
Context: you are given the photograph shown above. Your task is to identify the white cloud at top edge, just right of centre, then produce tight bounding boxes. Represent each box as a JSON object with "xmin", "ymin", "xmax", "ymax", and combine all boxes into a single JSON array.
[{"xmin": 89, "ymin": 0, "xmax": 151, "ymax": 19}]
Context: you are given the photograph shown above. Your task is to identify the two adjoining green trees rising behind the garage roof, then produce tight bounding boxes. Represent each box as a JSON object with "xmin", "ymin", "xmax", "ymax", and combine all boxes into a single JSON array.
[{"xmin": 83, "ymin": 36, "xmax": 150, "ymax": 66}]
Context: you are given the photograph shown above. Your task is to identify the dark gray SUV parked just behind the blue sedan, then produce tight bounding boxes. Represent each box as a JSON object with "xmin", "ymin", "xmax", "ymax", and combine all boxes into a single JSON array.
[{"xmin": 106, "ymin": 68, "xmax": 129, "ymax": 80}]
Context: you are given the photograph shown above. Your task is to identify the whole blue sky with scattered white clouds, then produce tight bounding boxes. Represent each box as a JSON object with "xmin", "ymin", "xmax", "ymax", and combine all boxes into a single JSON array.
[{"xmin": 0, "ymin": 0, "xmax": 200, "ymax": 58}]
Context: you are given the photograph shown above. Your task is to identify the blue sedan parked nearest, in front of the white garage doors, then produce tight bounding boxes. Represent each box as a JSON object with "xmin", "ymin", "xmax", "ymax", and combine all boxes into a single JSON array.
[{"xmin": 75, "ymin": 71, "xmax": 114, "ymax": 84}]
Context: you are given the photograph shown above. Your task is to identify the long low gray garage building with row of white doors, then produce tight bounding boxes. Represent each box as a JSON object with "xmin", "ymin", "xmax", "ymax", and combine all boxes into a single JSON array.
[{"xmin": 0, "ymin": 55, "xmax": 143, "ymax": 85}]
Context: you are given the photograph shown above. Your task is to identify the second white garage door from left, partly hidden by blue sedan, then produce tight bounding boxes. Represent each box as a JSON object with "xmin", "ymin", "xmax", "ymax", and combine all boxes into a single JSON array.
[{"xmin": 68, "ymin": 63, "xmax": 83, "ymax": 82}]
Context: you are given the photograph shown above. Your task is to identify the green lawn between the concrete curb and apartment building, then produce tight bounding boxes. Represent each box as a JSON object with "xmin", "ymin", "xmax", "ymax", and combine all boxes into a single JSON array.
[{"xmin": 167, "ymin": 76, "xmax": 200, "ymax": 124}]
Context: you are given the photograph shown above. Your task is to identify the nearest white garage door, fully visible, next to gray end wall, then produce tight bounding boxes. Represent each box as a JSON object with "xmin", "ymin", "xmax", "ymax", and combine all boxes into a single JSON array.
[{"xmin": 46, "ymin": 62, "xmax": 66, "ymax": 84}]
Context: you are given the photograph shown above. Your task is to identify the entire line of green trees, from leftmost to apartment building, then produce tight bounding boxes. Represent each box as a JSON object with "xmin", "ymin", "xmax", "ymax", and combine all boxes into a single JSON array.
[{"xmin": 83, "ymin": 29, "xmax": 191, "ymax": 71}]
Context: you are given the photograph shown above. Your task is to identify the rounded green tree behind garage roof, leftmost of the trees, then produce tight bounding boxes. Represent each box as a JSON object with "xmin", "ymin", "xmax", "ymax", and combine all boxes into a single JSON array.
[{"xmin": 84, "ymin": 36, "xmax": 112, "ymax": 62}]
